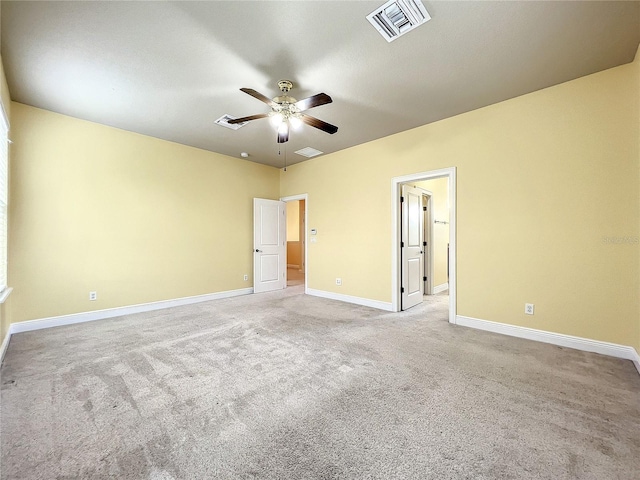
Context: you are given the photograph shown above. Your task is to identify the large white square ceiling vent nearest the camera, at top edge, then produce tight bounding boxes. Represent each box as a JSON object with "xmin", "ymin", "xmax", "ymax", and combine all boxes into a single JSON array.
[{"xmin": 367, "ymin": 0, "xmax": 431, "ymax": 42}]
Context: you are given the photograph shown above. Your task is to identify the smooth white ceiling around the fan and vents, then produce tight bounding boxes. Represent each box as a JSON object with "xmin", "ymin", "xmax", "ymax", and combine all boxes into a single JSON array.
[{"xmin": 0, "ymin": 0, "xmax": 640, "ymax": 167}]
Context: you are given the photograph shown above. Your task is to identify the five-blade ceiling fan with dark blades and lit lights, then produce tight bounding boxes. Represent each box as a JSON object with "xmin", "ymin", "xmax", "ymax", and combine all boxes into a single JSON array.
[{"xmin": 228, "ymin": 80, "xmax": 338, "ymax": 143}]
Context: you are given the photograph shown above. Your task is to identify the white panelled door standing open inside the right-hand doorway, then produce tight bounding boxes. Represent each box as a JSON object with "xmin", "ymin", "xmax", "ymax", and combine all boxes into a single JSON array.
[{"xmin": 400, "ymin": 185, "xmax": 426, "ymax": 310}]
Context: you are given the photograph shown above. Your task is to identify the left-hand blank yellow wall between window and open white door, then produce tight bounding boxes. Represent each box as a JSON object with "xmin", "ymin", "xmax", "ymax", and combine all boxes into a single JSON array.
[{"xmin": 9, "ymin": 103, "xmax": 279, "ymax": 322}]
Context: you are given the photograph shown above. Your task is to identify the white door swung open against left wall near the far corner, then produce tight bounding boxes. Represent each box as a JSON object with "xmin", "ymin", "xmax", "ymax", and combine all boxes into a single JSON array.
[{"xmin": 253, "ymin": 198, "xmax": 287, "ymax": 293}]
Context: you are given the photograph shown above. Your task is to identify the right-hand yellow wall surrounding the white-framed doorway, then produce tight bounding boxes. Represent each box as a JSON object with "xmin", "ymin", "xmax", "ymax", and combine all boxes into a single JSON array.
[{"xmin": 280, "ymin": 58, "xmax": 640, "ymax": 348}]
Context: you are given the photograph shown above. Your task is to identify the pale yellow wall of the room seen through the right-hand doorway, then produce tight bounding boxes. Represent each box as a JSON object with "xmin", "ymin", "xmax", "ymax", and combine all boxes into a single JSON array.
[{"xmin": 415, "ymin": 177, "xmax": 449, "ymax": 287}]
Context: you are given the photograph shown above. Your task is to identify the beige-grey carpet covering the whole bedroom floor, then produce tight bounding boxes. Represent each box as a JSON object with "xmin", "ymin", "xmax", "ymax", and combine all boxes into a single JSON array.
[{"xmin": 0, "ymin": 287, "xmax": 640, "ymax": 480}]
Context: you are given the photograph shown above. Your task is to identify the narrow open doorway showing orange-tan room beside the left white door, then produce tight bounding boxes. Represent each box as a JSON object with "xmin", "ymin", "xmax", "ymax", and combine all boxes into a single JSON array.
[{"xmin": 281, "ymin": 194, "xmax": 307, "ymax": 290}]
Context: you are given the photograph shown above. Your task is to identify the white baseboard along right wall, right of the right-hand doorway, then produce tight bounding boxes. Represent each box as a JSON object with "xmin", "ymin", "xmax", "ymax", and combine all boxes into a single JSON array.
[{"xmin": 456, "ymin": 315, "xmax": 640, "ymax": 374}]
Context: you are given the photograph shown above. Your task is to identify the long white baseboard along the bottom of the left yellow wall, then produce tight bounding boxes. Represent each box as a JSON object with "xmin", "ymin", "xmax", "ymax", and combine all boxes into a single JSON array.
[{"xmin": 9, "ymin": 288, "xmax": 253, "ymax": 335}]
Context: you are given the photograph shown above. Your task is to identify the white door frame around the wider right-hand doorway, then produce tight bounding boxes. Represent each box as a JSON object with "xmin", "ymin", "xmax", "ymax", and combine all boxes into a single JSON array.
[{"xmin": 391, "ymin": 167, "xmax": 457, "ymax": 324}]
